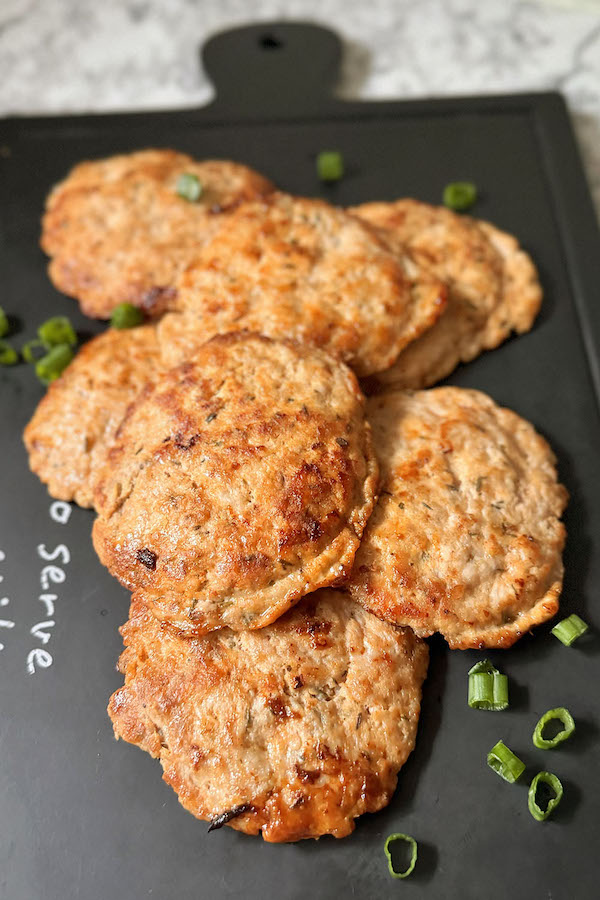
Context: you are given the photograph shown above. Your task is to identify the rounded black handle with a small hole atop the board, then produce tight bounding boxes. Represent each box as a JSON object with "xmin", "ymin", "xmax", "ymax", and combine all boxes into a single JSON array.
[{"xmin": 201, "ymin": 22, "xmax": 341, "ymax": 118}]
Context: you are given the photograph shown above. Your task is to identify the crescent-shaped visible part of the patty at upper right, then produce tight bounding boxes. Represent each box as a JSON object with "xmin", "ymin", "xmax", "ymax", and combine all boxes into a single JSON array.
[{"xmin": 353, "ymin": 199, "xmax": 542, "ymax": 388}]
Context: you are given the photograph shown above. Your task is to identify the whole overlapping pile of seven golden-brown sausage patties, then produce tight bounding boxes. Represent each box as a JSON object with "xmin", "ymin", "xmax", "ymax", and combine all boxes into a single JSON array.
[{"xmin": 25, "ymin": 150, "xmax": 566, "ymax": 841}]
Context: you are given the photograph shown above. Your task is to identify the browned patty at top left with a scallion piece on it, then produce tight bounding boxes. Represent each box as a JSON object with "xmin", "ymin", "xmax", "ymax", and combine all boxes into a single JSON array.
[{"xmin": 41, "ymin": 150, "xmax": 272, "ymax": 319}]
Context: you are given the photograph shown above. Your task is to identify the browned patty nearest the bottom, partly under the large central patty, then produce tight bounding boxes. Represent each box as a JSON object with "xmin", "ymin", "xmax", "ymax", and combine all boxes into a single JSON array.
[{"xmin": 108, "ymin": 590, "xmax": 428, "ymax": 841}]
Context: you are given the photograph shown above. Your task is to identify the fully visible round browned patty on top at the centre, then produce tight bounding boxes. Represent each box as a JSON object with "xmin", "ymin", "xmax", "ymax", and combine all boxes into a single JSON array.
[{"xmin": 93, "ymin": 334, "xmax": 378, "ymax": 634}]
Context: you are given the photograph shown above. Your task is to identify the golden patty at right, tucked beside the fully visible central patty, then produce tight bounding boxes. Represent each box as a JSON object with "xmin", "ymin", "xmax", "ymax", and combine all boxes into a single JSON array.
[{"xmin": 348, "ymin": 388, "xmax": 567, "ymax": 649}]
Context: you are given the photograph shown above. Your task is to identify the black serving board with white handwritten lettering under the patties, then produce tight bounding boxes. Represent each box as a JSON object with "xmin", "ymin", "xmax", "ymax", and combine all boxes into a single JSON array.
[{"xmin": 0, "ymin": 23, "xmax": 600, "ymax": 900}]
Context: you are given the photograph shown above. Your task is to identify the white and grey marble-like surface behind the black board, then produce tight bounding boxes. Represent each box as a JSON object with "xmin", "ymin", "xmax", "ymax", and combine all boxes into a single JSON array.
[{"xmin": 0, "ymin": 0, "xmax": 600, "ymax": 210}]
